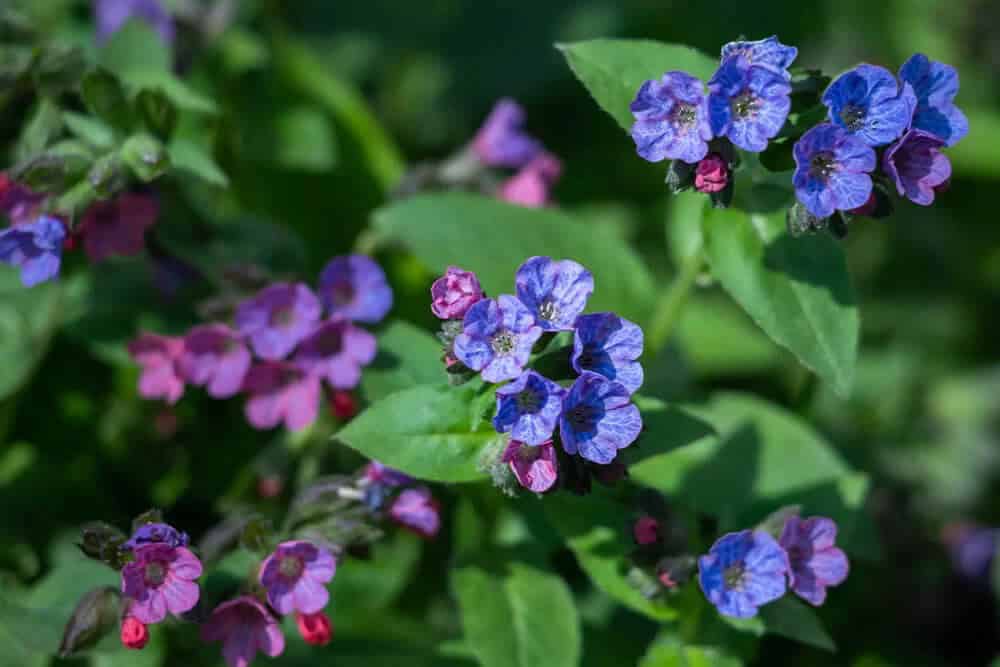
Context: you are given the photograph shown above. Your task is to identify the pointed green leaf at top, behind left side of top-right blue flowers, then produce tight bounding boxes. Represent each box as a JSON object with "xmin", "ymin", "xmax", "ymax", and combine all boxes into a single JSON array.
[{"xmin": 557, "ymin": 39, "xmax": 719, "ymax": 132}]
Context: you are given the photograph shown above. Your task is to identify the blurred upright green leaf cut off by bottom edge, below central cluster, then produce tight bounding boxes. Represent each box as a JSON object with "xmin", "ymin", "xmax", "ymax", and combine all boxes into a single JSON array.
[{"xmin": 451, "ymin": 563, "xmax": 581, "ymax": 667}]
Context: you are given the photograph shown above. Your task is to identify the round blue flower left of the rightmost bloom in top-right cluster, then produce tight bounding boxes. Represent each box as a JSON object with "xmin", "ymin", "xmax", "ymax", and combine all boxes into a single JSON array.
[{"xmin": 823, "ymin": 64, "xmax": 917, "ymax": 146}]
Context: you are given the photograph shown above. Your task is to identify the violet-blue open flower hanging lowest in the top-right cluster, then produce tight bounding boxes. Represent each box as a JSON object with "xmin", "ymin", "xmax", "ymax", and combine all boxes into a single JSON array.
[{"xmin": 792, "ymin": 123, "xmax": 876, "ymax": 218}]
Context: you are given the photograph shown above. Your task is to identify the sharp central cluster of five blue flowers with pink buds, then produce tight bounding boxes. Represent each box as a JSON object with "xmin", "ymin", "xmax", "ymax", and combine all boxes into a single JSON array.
[{"xmin": 431, "ymin": 257, "xmax": 643, "ymax": 493}]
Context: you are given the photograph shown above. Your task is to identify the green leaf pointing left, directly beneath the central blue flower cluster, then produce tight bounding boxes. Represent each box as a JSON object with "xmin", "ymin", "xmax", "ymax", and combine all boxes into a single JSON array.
[{"xmin": 336, "ymin": 385, "xmax": 503, "ymax": 482}]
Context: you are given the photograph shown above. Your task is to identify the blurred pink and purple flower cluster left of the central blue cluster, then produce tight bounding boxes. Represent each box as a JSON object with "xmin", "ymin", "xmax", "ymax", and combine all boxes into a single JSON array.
[{"xmin": 129, "ymin": 255, "xmax": 392, "ymax": 431}]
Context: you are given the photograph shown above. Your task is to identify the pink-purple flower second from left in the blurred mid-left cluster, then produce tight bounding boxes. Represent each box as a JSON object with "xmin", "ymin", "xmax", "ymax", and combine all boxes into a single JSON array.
[{"xmin": 180, "ymin": 324, "xmax": 252, "ymax": 398}]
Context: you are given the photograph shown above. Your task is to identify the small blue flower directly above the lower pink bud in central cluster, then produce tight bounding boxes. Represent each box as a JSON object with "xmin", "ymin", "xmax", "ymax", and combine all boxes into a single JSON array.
[{"xmin": 493, "ymin": 371, "xmax": 566, "ymax": 445}]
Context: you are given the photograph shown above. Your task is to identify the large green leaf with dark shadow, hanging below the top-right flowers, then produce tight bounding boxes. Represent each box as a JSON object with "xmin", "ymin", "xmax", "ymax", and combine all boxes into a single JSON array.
[{"xmin": 704, "ymin": 209, "xmax": 860, "ymax": 396}]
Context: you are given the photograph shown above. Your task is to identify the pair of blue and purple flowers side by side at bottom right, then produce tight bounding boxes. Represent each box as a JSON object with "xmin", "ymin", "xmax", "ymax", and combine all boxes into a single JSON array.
[{"xmin": 698, "ymin": 515, "xmax": 849, "ymax": 618}]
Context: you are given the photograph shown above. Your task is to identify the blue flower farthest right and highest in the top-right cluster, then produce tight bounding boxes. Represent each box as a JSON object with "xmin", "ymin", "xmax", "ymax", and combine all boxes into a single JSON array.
[{"xmin": 899, "ymin": 53, "xmax": 969, "ymax": 146}]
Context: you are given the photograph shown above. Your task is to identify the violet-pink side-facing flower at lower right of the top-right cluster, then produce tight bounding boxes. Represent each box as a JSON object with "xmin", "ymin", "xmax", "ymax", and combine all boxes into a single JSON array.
[{"xmin": 882, "ymin": 130, "xmax": 951, "ymax": 206}]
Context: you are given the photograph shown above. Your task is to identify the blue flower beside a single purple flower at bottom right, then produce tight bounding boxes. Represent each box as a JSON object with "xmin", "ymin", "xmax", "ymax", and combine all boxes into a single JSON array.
[{"xmin": 698, "ymin": 530, "xmax": 788, "ymax": 618}]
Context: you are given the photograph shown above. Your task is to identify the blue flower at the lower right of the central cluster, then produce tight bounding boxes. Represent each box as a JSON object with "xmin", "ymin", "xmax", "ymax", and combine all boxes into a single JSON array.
[{"xmin": 559, "ymin": 371, "xmax": 642, "ymax": 464}]
